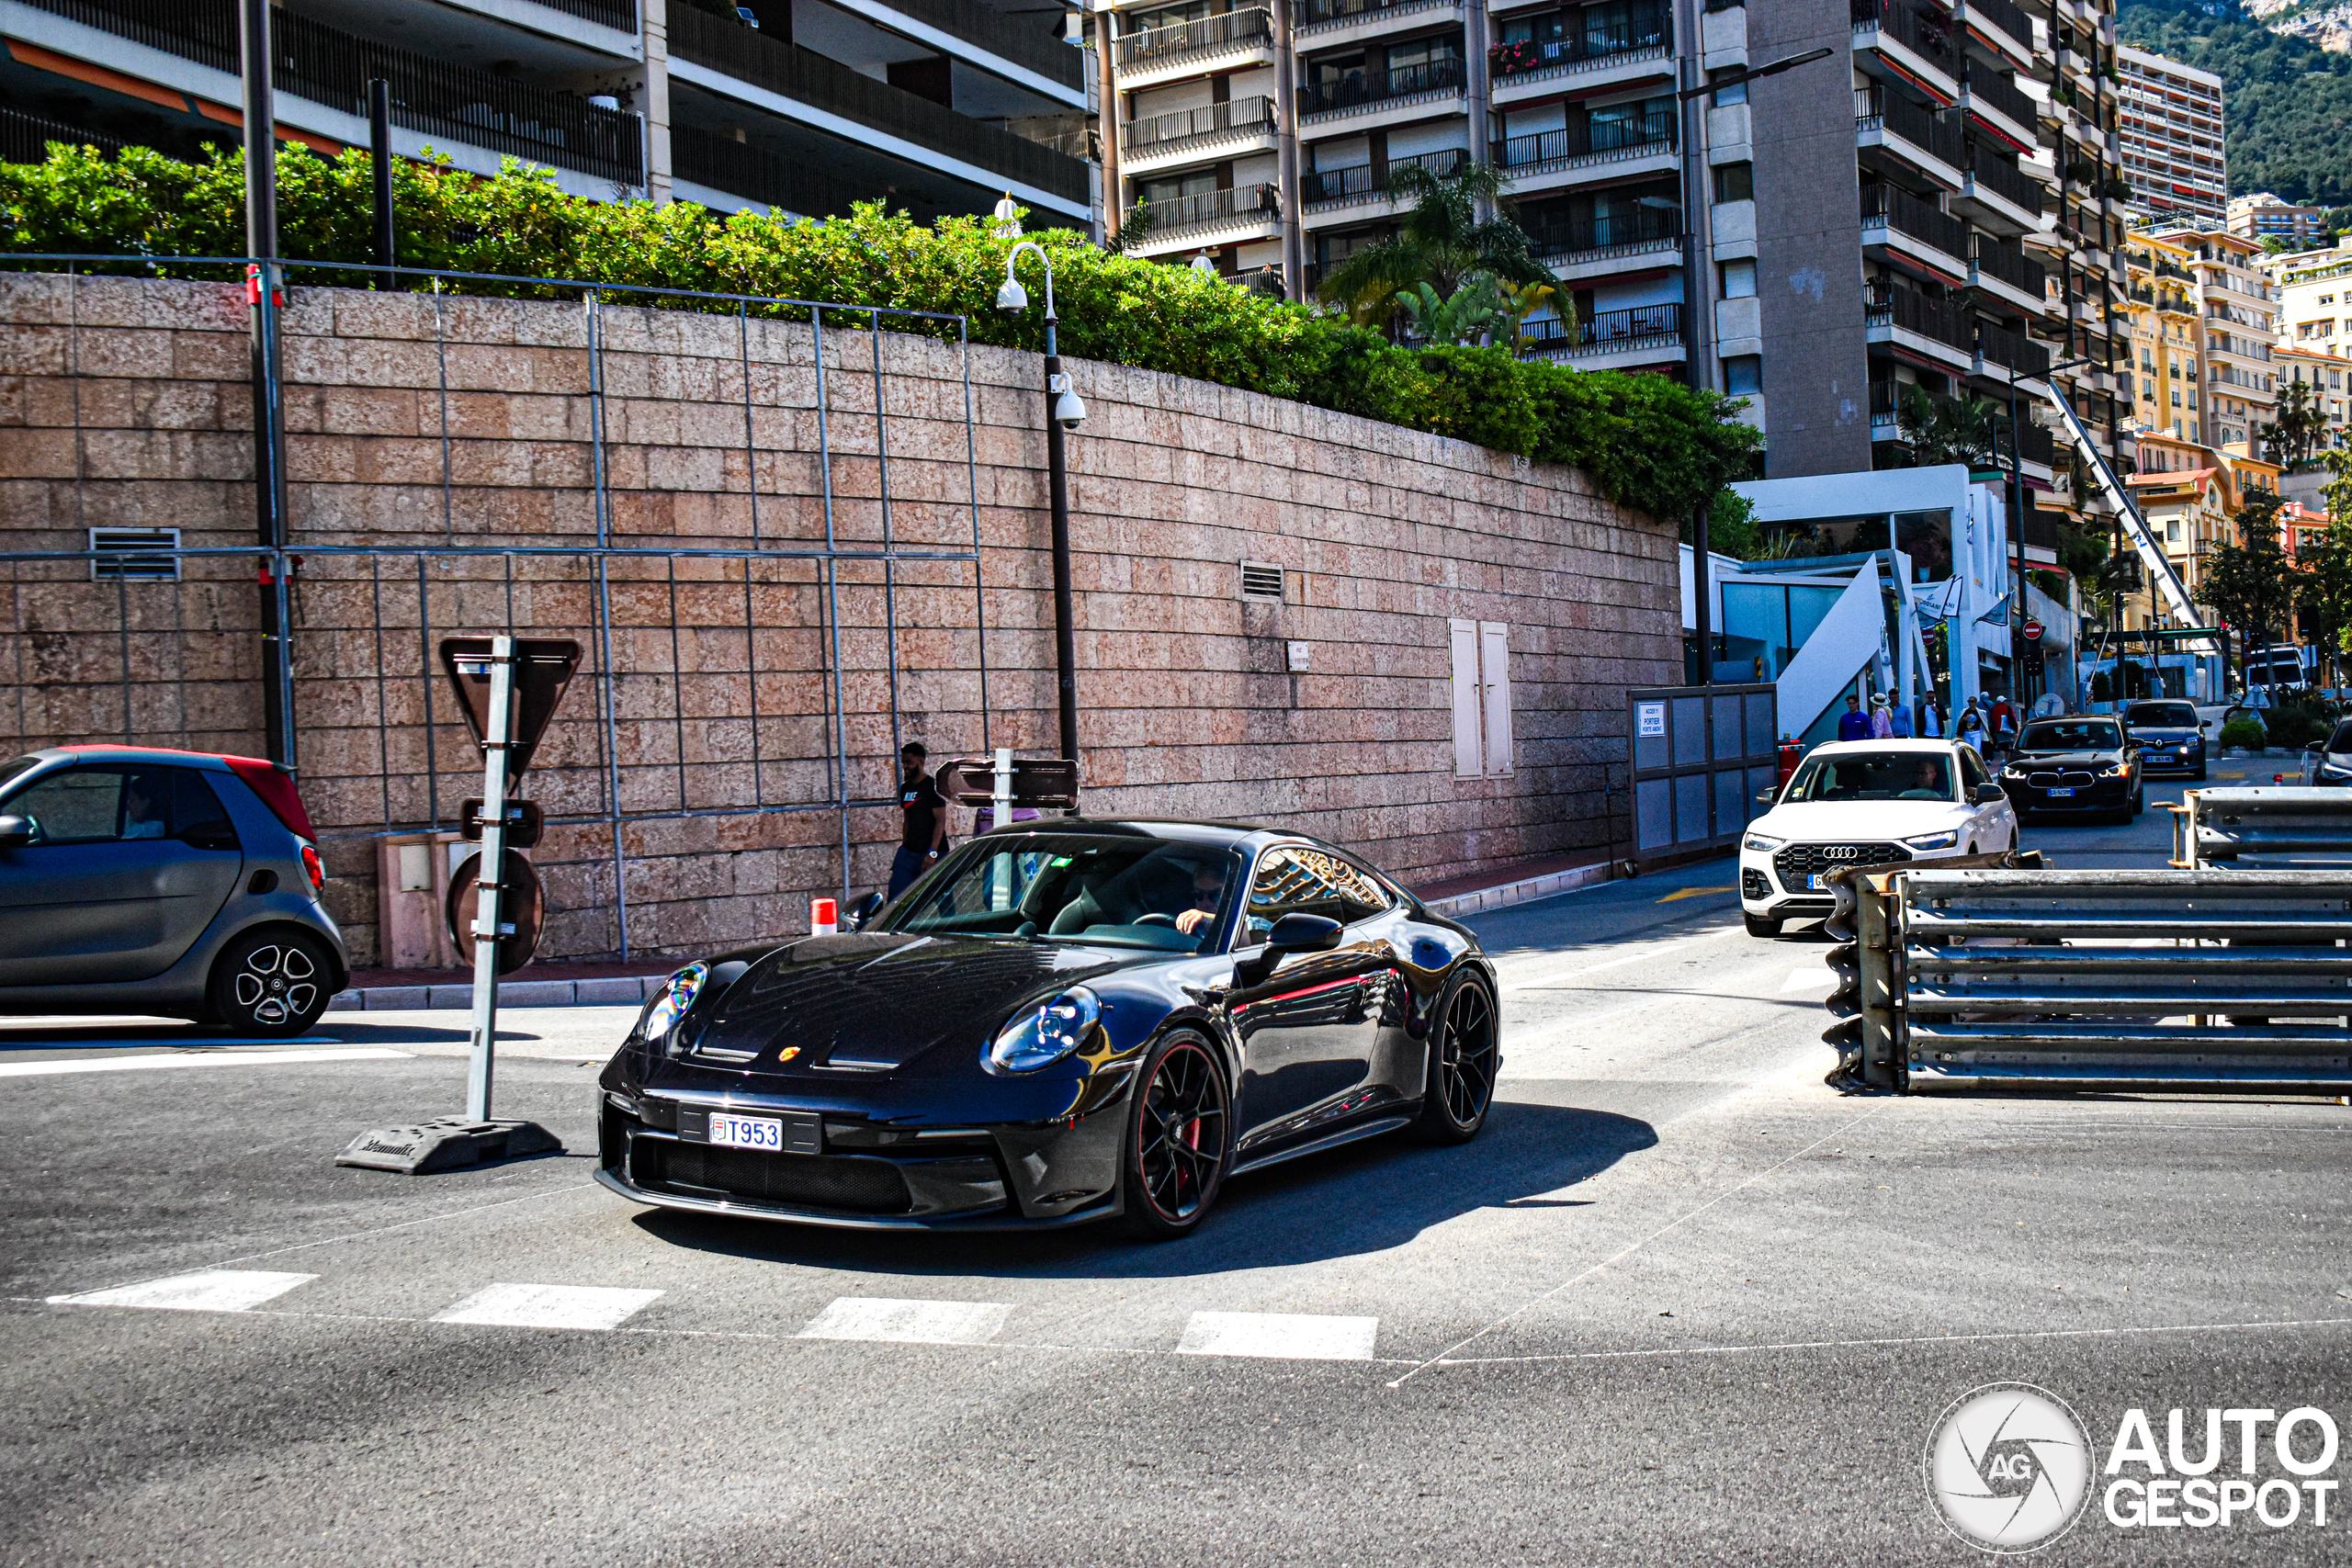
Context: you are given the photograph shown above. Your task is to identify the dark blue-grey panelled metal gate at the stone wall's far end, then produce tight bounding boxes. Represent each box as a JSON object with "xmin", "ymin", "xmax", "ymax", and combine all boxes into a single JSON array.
[{"xmin": 1625, "ymin": 682, "xmax": 1781, "ymax": 861}]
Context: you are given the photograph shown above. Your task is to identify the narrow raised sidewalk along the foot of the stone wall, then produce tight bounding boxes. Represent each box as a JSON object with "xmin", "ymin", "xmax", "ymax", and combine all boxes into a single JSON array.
[{"xmin": 327, "ymin": 849, "xmax": 1609, "ymax": 1013}]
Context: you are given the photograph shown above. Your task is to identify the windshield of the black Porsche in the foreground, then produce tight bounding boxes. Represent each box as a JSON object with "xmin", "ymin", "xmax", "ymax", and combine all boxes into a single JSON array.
[{"xmin": 875, "ymin": 832, "xmax": 1242, "ymax": 952}]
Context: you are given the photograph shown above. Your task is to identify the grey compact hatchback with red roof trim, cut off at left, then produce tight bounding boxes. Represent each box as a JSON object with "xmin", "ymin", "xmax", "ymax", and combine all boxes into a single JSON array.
[{"xmin": 0, "ymin": 745, "xmax": 350, "ymax": 1034}]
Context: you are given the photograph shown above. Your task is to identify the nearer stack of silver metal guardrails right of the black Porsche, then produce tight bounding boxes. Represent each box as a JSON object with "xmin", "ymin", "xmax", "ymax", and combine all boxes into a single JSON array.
[{"xmin": 1823, "ymin": 863, "xmax": 2352, "ymax": 1093}]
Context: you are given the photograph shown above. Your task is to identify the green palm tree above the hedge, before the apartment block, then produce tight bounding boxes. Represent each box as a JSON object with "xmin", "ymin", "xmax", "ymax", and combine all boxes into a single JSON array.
[{"xmin": 1319, "ymin": 164, "xmax": 1553, "ymax": 327}]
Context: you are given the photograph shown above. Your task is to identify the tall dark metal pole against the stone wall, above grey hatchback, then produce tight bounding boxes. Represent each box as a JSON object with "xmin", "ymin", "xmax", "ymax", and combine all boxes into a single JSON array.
[{"xmin": 238, "ymin": 0, "xmax": 291, "ymax": 764}]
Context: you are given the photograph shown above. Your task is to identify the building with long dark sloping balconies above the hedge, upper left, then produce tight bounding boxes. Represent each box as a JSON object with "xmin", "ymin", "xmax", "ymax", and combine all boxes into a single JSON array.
[{"xmin": 0, "ymin": 0, "xmax": 1096, "ymax": 226}]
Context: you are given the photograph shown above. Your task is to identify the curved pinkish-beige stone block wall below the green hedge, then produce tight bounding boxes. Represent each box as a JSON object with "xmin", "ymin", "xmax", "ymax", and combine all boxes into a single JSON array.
[{"xmin": 0, "ymin": 275, "xmax": 1679, "ymax": 962}]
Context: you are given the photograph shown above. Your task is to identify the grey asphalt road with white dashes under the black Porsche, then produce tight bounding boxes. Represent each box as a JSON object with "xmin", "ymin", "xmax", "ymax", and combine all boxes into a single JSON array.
[{"xmin": 0, "ymin": 757, "xmax": 2352, "ymax": 1565}]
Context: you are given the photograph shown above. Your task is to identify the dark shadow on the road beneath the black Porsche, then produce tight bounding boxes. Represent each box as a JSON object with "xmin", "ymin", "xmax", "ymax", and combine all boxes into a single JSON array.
[{"xmin": 635, "ymin": 1100, "xmax": 1658, "ymax": 1279}]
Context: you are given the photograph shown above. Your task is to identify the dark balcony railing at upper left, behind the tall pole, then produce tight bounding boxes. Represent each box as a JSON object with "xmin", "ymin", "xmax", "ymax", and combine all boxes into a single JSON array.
[{"xmin": 28, "ymin": 0, "xmax": 644, "ymax": 186}]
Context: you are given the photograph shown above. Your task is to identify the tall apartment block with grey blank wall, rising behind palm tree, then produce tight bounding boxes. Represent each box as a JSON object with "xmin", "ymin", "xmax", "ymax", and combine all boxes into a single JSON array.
[{"xmin": 1099, "ymin": 0, "xmax": 2129, "ymax": 487}]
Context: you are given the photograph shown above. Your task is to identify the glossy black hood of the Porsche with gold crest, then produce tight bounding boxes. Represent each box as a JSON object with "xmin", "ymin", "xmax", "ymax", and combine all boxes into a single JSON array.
[{"xmin": 694, "ymin": 931, "xmax": 1133, "ymax": 1072}]
